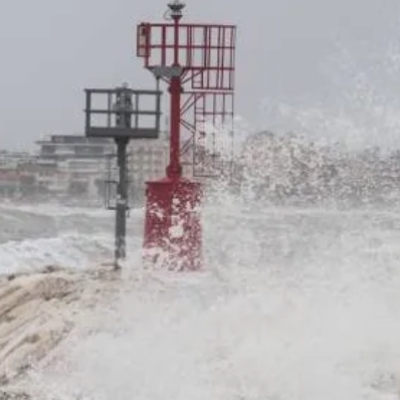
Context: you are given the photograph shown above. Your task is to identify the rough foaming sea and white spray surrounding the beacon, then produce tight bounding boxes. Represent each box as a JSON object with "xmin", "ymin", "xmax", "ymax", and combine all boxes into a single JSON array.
[{"xmin": 0, "ymin": 199, "xmax": 400, "ymax": 400}]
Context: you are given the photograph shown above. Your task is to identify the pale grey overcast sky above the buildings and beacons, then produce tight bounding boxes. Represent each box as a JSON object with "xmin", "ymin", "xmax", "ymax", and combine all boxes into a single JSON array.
[{"xmin": 0, "ymin": 0, "xmax": 400, "ymax": 149}]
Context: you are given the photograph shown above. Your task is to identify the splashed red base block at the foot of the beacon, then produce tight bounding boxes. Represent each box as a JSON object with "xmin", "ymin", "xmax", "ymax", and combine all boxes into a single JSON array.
[{"xmin": 144, "ymin": 177, "xmax": 202, "ymax": 270}]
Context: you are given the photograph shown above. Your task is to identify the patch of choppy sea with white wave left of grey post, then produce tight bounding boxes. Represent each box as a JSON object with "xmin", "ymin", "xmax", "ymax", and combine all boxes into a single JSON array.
[{"xmin": 0, "ymin": 204, "xmax": 120, "ymax": 274}]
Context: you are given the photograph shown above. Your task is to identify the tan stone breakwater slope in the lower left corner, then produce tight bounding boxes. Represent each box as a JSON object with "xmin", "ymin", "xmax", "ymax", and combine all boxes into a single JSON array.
[{"xmin": 0, "ymin": 267, "xmax": 122, "ymax": 400}]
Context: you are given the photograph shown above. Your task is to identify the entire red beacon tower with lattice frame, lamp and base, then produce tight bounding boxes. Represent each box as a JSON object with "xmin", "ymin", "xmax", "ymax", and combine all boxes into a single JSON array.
[{"xmin": 137, "ymin": 0, "xmax": 236, "ymax": 269}]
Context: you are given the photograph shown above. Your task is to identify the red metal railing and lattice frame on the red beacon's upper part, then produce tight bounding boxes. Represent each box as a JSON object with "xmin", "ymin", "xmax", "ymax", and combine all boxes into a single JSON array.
[{"xmin": 137, "ymin": 17, "xmax": 236, "ymax": 176}]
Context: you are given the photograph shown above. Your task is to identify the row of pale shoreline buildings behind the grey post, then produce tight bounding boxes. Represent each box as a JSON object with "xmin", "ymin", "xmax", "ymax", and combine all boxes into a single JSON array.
[{"xmin": 0, "ymin": 132, "xmax": 169, "ymax": 205}]
